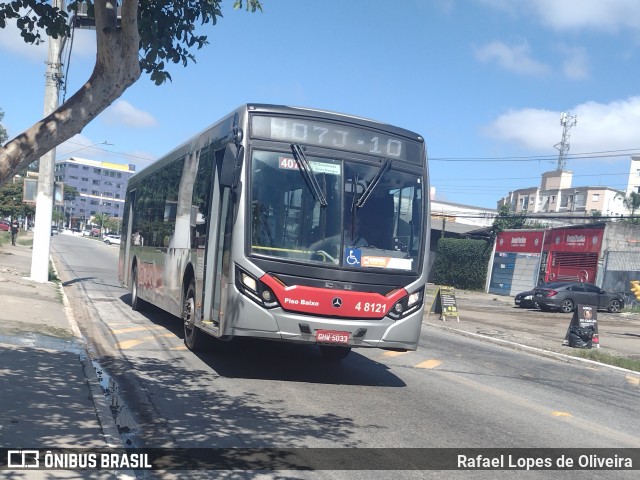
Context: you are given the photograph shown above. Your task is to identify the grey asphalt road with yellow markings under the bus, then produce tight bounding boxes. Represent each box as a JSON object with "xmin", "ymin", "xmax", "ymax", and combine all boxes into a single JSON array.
[{"xmin": 52, "ymin": 235, "xmax": 640, "ymax": 478}]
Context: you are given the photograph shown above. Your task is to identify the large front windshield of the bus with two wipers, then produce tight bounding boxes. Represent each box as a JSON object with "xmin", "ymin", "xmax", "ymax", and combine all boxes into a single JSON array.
[{"xmin": 249, "ymin": 145, "xmax": 423, "ymax": 272}]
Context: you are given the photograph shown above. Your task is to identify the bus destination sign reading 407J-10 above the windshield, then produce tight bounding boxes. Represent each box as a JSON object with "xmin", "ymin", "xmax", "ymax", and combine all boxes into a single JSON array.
[{"xmin": 251, "ymin": 115, "xmax": 421, "ymax": 163}]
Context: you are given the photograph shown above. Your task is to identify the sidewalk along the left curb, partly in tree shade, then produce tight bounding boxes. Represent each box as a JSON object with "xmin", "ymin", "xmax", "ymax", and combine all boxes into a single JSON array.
[{"xmin": 0, "ymin": 240, "xmax": 121, "ymax": 454}]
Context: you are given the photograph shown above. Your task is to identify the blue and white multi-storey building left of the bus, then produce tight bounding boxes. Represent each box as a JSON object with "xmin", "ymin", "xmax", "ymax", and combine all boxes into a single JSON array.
[{"xmin": 54, "ymin": 157, "xmax": 135, "ymax": 226}]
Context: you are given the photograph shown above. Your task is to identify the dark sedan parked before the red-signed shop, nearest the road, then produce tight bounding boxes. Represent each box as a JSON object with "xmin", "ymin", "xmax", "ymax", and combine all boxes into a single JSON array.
[{"xmin": 533, "ymin": 282, "xmax": 624, "ymax": 313}]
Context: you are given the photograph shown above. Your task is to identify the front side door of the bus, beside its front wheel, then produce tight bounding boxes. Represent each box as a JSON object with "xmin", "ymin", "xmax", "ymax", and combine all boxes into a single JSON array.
[{"xmin": 202, "ymin": 148, "xmax": 233, "ymax": 335}]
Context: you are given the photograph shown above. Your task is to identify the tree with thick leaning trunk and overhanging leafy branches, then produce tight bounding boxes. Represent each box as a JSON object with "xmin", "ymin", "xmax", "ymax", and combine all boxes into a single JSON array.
[{"xmin": 0, "ymin": 0, "xmax": 262, "ymax": 186}]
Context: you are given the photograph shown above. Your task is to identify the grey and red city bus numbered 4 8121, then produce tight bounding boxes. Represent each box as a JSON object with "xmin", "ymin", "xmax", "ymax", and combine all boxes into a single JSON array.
[{"xmin": 118, "ymin": 104, "xmax": 430, "ymax": 360}]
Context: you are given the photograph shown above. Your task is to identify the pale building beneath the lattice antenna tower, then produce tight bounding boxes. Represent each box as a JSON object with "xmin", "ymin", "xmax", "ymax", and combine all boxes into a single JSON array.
[{"xmin": 498, "ymin": 170, "xmax": 628, "ymax": 220}]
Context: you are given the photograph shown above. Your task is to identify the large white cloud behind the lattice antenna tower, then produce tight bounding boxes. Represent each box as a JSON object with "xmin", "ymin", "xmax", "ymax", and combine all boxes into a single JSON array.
[{"xmin": 483, "ymin": 96, "xmax": 640, "ymax": 153}]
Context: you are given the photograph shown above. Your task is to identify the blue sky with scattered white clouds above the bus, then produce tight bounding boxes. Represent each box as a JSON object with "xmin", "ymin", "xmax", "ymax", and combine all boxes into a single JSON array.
[{"xmin": 0, "ymin": 0, "xmax": 640, "ymax": 208}]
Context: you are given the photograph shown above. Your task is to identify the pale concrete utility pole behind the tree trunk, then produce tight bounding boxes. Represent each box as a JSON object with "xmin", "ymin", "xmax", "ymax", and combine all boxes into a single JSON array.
[{"xmin": 31, "ymin": 0, "xmax": 65, "ymax": 282}]
